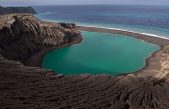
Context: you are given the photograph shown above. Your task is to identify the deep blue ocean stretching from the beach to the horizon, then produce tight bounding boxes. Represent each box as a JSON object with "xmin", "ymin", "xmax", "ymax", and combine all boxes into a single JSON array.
[{"xmin": 34, "ymin": 5, "xmax": 169, "ymax": 37}]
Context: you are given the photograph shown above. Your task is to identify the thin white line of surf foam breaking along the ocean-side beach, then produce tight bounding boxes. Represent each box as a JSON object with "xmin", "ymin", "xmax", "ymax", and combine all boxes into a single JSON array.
[{"xmin": 78, "ymin": 25, "xmax": 169, "ymax": 40}]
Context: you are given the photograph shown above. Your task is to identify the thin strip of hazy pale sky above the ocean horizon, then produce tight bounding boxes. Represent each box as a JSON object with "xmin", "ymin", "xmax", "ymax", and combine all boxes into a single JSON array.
[{"xmin": 0, "ymin": 0, "xmax": 169, "ymax": 6}]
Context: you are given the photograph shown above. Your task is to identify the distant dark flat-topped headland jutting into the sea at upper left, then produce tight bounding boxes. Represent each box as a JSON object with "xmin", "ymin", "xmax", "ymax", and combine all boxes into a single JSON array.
[{"xmin": 0, "ymin": 6, "xmax": 37, "ymax": 15}]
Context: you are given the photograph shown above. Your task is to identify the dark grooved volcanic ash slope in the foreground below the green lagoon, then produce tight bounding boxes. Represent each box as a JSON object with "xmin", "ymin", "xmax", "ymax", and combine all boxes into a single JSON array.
[{"xmin": 0, "ymin": 47, "xmax": 169, "ymax": 109}]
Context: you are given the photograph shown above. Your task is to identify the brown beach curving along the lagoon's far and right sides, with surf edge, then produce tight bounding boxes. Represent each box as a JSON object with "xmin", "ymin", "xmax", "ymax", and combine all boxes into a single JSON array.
[{"xmin": 78, "ymin": 26, "xmax": 169, "ymax": 76}]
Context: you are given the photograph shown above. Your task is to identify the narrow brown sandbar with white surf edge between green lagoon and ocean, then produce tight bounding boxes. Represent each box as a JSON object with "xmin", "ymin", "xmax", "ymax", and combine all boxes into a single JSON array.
[{"xmin": 78, "ymin": 26, "xmax": 169, "ymax": 46}]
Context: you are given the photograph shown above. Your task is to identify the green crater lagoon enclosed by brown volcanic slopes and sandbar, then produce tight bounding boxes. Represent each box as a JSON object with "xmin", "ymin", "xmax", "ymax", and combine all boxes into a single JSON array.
[{"xmin": 42, "ymin": 32, "xmax": 160, "ymax": 75}]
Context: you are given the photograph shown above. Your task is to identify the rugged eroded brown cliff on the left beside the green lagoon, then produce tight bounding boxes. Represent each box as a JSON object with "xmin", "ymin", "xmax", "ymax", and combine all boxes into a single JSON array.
[{"xmin": 0, "ymin": 14, "xmax": 80, "ymax": 63}]
